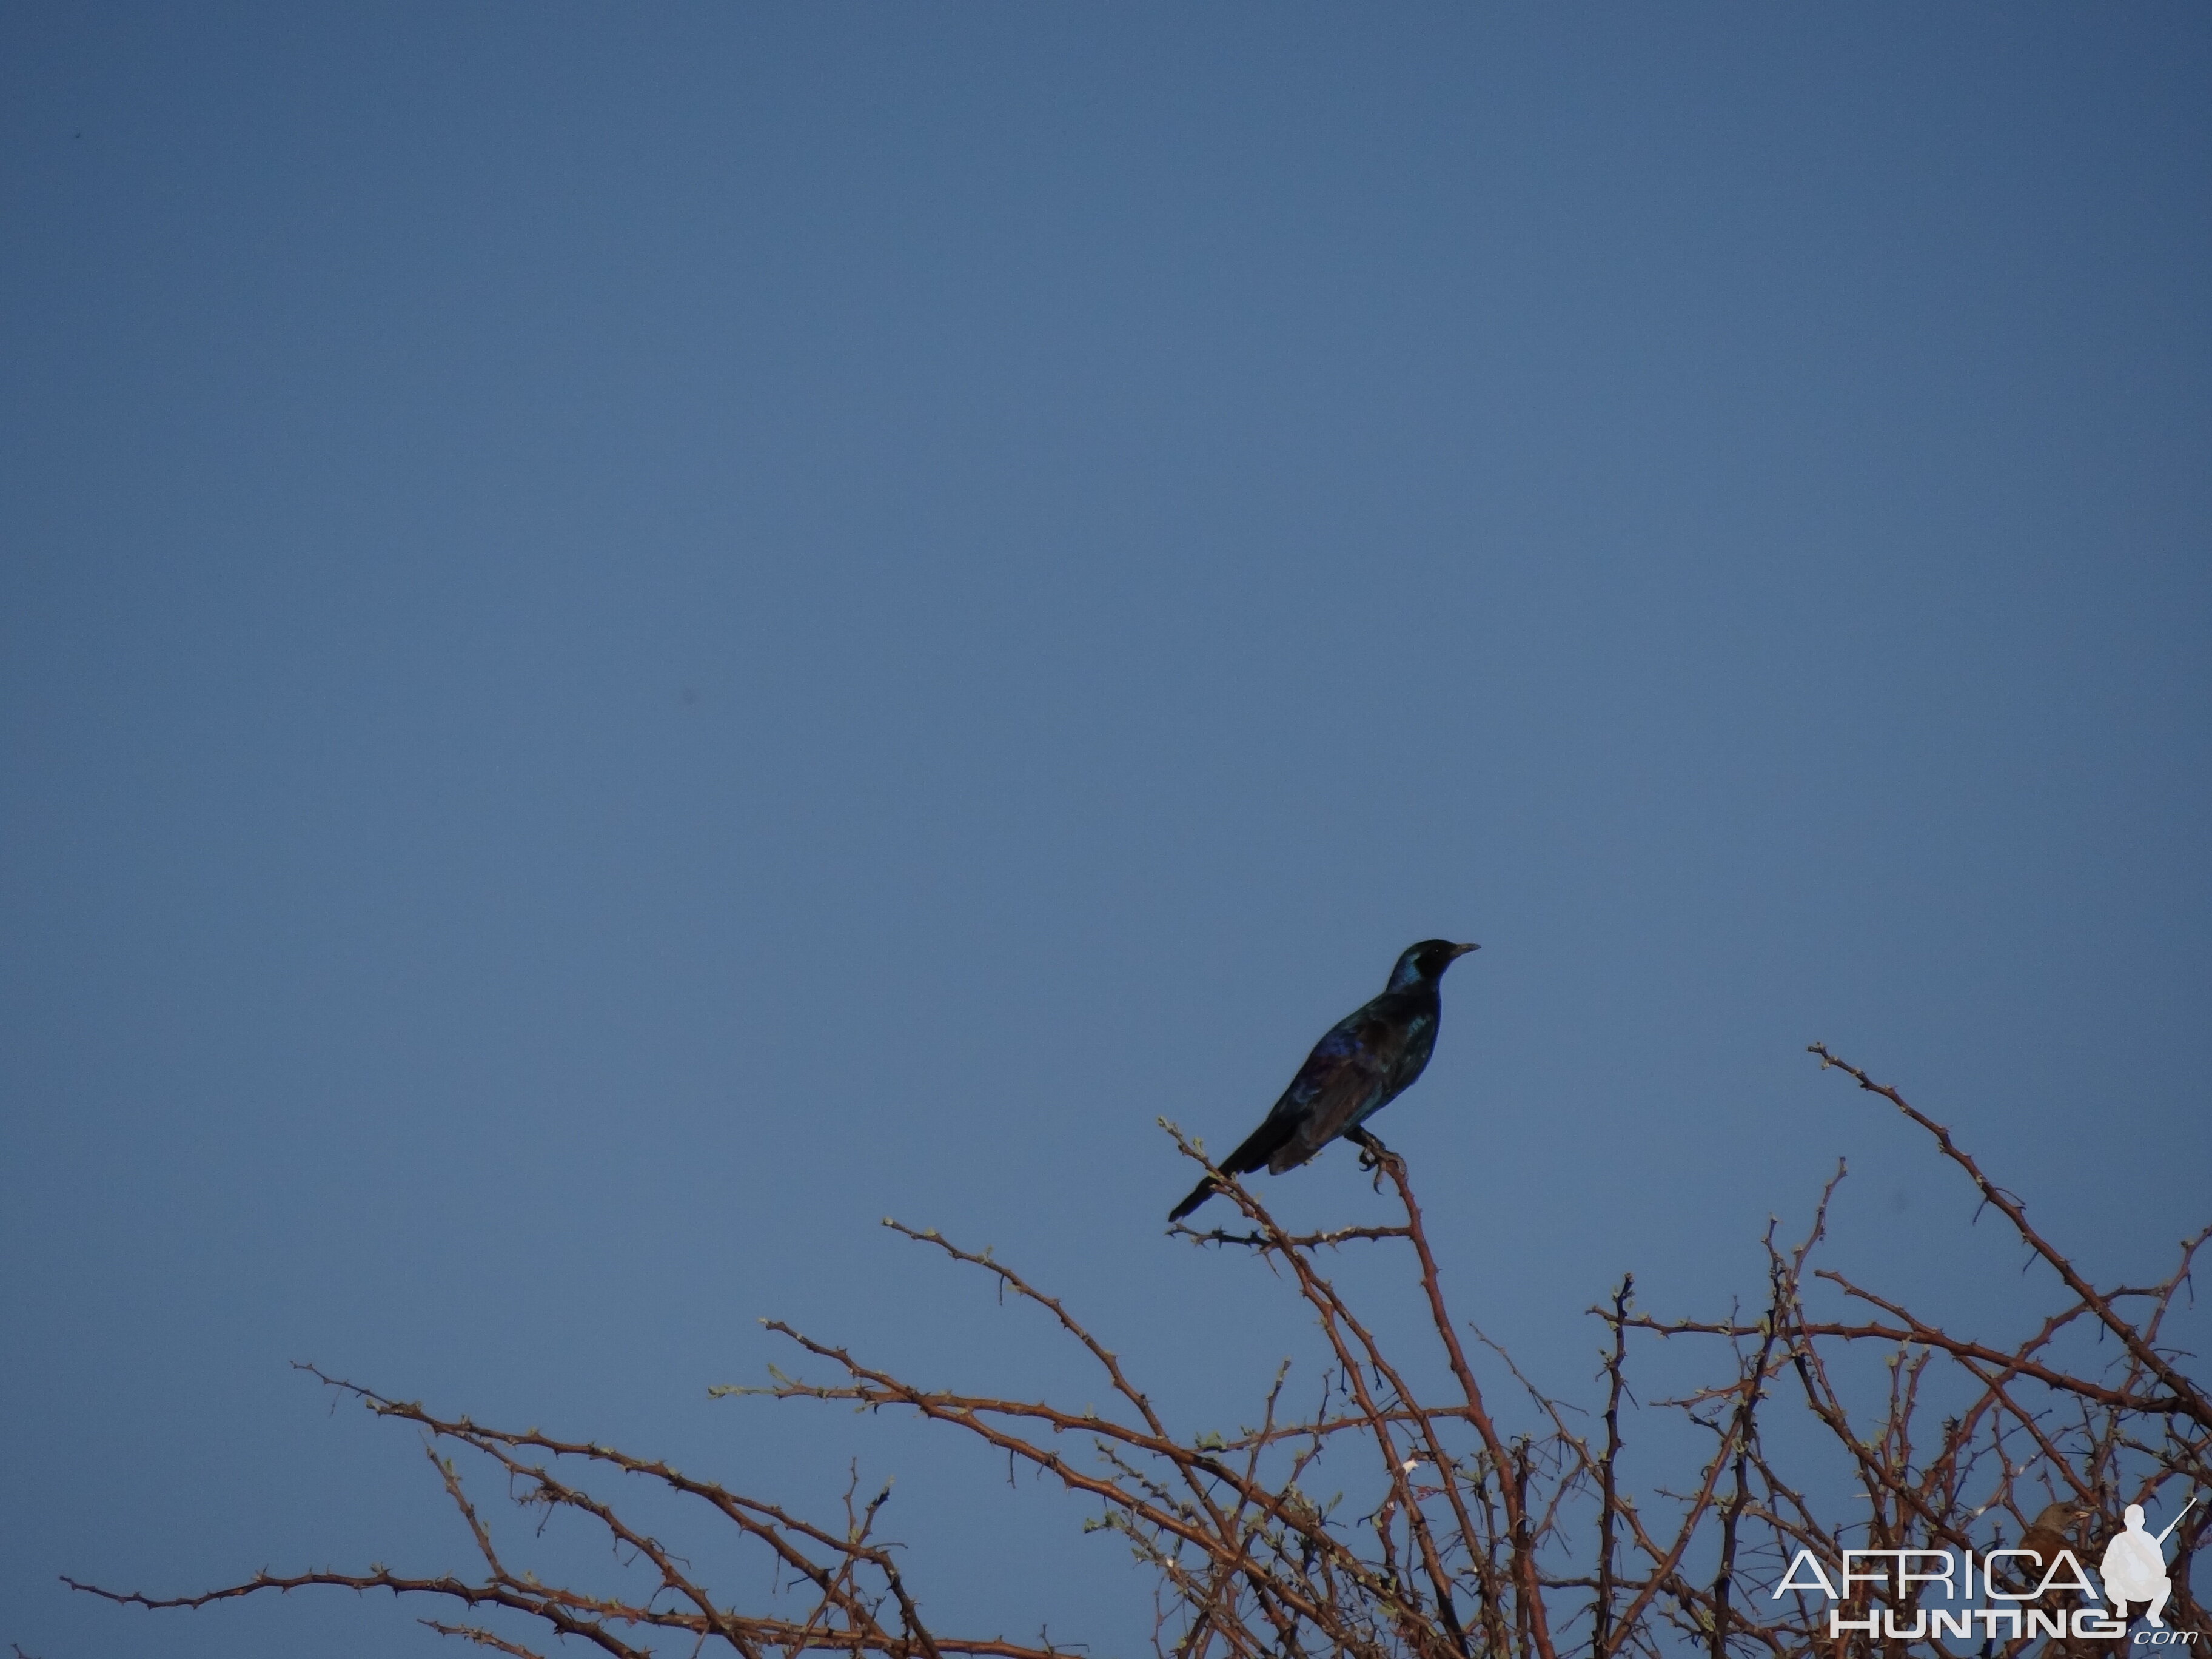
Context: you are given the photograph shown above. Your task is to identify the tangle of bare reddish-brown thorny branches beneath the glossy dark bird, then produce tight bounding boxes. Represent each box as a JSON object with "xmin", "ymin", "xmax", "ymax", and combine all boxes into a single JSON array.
[{"xmin": 66, "ymin": 1044, "xmax": 2212, "ymax": 1659}]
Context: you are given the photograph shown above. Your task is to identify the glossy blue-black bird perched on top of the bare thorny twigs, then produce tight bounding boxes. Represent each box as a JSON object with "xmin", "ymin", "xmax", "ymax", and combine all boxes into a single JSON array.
[{"xmin": 1168, "ymin": 938, "xmax": 1482, "ymax": 1223}]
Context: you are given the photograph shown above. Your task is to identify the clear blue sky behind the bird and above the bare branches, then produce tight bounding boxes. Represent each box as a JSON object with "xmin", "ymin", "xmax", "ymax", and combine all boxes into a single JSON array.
[{"xmin": 0, "ymin": 2, "xmax": 2212, "ymax": 1659}]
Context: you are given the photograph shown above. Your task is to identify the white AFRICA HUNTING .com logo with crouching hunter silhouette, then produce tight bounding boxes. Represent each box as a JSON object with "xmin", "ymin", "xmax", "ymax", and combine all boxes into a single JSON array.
[{"xmin": 1774, "ymin": 1498, "xmax": 2199, "ymax": 1646}]
